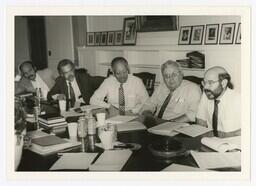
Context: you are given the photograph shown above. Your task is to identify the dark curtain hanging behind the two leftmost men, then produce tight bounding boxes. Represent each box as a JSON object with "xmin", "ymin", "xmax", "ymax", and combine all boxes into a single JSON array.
[{"xmin": 27, "ymin": 16, "xmax": 48, "ymax": 70}]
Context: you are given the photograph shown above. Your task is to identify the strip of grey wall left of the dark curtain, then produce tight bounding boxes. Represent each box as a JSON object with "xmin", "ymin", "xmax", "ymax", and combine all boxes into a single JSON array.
[{"xmin": 15, "ymin": 16, "xmax": 30, "ymax": 74}]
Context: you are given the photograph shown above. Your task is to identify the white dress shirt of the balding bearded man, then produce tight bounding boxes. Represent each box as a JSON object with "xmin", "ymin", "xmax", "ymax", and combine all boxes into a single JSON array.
[{"xmin": 196, "ymin": 88, "xmax": 241, "ymax": 132}]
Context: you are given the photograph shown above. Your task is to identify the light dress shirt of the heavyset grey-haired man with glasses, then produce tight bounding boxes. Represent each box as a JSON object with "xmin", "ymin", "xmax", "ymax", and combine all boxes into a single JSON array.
[{"xmin": 141, "ymin": 80, "xmax": 202, "ymax": 121}]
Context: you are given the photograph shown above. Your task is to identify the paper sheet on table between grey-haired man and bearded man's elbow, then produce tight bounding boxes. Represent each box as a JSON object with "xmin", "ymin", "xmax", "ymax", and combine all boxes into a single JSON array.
[{"xmin": 175, "ymin": 125, "xmax": 212, "ymax": 137}]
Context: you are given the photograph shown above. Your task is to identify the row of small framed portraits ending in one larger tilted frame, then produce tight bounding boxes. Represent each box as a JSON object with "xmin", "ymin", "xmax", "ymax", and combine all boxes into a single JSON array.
[{"xmin": 86, "ymin": 17, "xmax": 137, "ymax": 46}]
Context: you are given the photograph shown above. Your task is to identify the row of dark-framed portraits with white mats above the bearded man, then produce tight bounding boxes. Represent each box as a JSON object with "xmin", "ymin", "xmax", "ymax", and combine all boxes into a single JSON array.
[{"xmin": 178, "ymin": 23, "xmax": 241, "ymax": 45}]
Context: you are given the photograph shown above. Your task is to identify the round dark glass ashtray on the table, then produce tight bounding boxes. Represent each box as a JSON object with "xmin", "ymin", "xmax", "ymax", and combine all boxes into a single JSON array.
[{"xmin": 148, "ymin": 138, "xmax": 186, "ymax": 158}]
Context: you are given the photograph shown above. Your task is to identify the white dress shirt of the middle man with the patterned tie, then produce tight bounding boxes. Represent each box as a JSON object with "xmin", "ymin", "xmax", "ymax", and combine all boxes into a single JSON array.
[{"xmin": 90, "ymin": 74, "xmax": 148, "ymax": 113}]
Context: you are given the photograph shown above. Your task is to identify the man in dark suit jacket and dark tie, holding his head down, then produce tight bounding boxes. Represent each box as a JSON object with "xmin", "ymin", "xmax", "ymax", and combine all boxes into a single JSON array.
[{"xmin": 47, "ymin": 59, "xmax": 93, "ymax": 109}]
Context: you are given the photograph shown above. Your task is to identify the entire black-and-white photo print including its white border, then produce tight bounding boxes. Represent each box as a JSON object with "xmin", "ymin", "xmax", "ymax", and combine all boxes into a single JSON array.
[{"xmin": 5, "ymin": 7, "xmax": 251, "ymax": 183}]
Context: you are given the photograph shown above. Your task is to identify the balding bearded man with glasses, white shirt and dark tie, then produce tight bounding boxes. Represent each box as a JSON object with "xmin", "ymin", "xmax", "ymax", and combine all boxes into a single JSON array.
[{"xmin": 196, "ymin": 66, "xmax": 241, "ymax": 137}]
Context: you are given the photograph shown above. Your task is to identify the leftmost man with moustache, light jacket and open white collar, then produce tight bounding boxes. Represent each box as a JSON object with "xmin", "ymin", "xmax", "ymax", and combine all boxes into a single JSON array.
[{"xmin": 15, "ymin": 61, "xmax": 56, "ymax": 98}]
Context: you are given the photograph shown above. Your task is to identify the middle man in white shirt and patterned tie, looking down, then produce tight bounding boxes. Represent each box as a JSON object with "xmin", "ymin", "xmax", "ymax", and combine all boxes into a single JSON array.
[{"xmin": 90, "ymin": 57, "xmax": 148, "ymax": 115}]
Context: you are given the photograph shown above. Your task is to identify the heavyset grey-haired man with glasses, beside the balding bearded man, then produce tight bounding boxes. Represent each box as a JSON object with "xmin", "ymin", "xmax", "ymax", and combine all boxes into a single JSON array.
[{"xmin": 141, "ymin": 60, "xmax": 201, "ymax": 127}]
